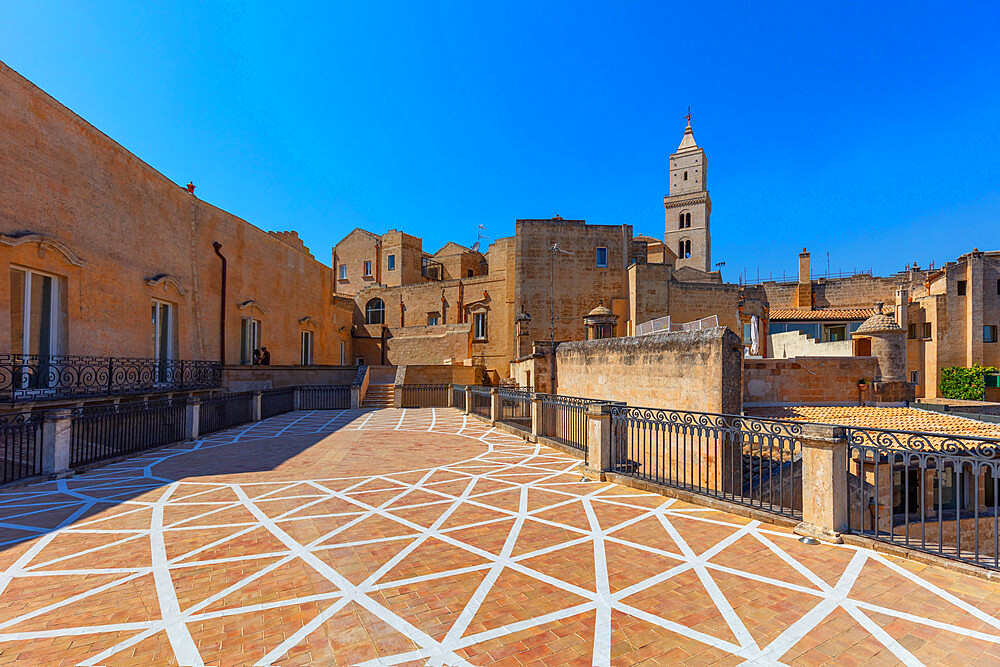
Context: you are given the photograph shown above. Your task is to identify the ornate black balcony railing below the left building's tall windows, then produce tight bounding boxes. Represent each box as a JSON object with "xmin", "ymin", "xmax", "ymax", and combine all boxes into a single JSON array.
[{"xmin": 0, "ymin": 354, "xmax": 222, "ymax": 403}]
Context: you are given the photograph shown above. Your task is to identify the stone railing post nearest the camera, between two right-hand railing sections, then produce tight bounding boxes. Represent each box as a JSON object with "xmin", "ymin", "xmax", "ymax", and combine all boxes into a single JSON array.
[{"xmin": 795, "ymin": 424, "xmax": 848, "ymax": 543}]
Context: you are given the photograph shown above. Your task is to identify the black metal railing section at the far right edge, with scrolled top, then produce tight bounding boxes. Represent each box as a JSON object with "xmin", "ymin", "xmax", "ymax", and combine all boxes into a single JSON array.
[{"xmin": 847, "ymin": 428, "xmax": 1000, "ymax": 569}]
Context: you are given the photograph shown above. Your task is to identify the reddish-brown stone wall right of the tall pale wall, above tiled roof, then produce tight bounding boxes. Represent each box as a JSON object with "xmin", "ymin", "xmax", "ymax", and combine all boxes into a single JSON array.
[{"xmin": 743, "ymin": 357, "xmax": 878, "ymax": 405}]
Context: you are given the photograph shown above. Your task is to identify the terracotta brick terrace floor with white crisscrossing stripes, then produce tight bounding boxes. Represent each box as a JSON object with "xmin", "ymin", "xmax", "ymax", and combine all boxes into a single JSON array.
[{"xmin": 0, "ymin": 408, "xmax": 1000, "ymax": 665}]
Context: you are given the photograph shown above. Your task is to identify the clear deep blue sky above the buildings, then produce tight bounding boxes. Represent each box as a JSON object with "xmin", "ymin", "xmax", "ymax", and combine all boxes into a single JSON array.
[{"xmin": 7, "ymin": 2, "xmax": 1000, "ymax": 281}]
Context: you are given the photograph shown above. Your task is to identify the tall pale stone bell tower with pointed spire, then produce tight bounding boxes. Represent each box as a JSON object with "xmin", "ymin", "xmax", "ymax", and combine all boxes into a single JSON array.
[{"xmin": 663, "ymin": 113, "xmax": 712, "ymax": 271}]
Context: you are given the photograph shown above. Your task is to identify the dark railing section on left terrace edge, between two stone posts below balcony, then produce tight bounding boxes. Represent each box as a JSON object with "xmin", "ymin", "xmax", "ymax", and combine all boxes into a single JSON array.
[{"xmin": 69, "ymin": 399, "xmax": 187, "ymax": 468}]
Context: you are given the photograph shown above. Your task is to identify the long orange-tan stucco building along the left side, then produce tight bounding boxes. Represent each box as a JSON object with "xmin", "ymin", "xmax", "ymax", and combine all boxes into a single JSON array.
[{"xmin": 0, "ymin": 63, "xmax": 354, "ymax": 365}]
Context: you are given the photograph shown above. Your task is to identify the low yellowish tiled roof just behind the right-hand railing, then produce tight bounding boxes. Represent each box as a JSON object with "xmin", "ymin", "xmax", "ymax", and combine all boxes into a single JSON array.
[{"xmin": 744, "ymin": 405, "xmax": 1000, "ymax": 438}]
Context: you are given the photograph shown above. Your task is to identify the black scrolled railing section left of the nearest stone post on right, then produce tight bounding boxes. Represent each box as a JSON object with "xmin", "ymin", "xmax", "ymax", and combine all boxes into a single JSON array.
[{"xmin": 610, "ymin": 405, "xmax": 802, "ymax": 518}]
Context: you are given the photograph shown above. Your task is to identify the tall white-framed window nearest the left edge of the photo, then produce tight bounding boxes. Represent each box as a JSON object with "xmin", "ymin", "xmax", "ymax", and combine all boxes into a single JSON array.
[{"xmin": 10, "ymin": 268, "xmax": 66, "ymax": 357}]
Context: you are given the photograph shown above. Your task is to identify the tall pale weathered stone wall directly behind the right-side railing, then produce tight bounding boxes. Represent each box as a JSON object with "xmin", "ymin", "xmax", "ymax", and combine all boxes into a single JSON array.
[{"xmin": 556, "ymin": 327, "xmax": 742, "ymax": 414}]
